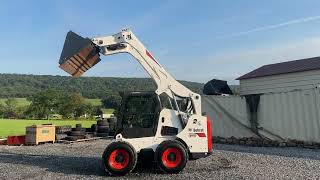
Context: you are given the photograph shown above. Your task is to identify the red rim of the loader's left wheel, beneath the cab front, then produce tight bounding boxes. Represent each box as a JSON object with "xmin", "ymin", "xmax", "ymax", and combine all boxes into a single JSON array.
[{"xmin": 109, "ymin": 149, "xmax": 129, "ymax": 170}]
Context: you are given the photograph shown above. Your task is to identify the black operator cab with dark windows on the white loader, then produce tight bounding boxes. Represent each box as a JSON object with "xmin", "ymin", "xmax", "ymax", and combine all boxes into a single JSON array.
[{"xmin": 116, "ymin": 92, "xmax": 194, "ymax": 138}]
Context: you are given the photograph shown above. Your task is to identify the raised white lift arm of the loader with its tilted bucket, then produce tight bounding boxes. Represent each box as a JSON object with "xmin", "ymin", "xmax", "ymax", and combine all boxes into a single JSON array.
[{"xmin": 60, "ymin": 29, "xmax": 201, "ymax": 114}]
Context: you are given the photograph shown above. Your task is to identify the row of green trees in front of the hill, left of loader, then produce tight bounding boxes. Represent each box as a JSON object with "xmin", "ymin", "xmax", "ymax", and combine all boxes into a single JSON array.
[{"xmin": 0, "ymin": 90, "xmax": 106, "ymax": 119}]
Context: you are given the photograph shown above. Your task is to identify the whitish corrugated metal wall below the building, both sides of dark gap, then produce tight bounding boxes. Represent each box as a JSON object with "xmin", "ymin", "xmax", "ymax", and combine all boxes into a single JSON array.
[{"xmin": 202, "ymin": 88, "xmax": 320, "ymax": 142}]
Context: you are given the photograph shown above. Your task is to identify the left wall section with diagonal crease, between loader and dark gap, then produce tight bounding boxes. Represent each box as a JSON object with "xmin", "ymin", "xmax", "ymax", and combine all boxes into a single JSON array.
[{"xmin": 202, "ymin": 96, "xmax": 255, "ymax": 138}]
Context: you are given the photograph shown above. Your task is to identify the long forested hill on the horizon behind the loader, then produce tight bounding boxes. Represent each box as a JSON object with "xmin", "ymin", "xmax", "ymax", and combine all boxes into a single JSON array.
[{"xmin": 0, "ymin": 74, "xmax": 203, "ymax": 98}]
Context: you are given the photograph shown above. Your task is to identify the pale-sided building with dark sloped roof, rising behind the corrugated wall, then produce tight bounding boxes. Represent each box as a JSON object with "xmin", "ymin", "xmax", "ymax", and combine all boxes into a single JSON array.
[{"xmin": 237, "ymin": 57, "xmax": 320, "ymax": 95}]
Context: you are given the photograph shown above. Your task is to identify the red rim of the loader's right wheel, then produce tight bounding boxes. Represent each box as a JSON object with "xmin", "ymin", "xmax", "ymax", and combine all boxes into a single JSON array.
[{"xmin": 161, "ymin": 148, "xmax": 182, "ymax": 168}]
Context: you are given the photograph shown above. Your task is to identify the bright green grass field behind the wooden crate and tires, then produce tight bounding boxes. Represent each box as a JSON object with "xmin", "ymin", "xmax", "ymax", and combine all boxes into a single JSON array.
[{"xmin": 0, "ymin": 119, "xmax": 96, "ymax": 138}]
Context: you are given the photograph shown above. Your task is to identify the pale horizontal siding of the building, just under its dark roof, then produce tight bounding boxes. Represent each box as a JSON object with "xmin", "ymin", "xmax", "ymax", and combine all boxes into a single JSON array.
[{"xmin": 240, "ymin": 70, "xmax": 320, "ymax": 95}]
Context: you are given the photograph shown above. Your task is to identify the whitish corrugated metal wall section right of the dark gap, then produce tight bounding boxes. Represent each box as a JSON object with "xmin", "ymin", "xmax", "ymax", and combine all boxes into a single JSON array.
[{"xmin": 258, "ymin": 88, "xmax": 320, "ymax": 142}]
